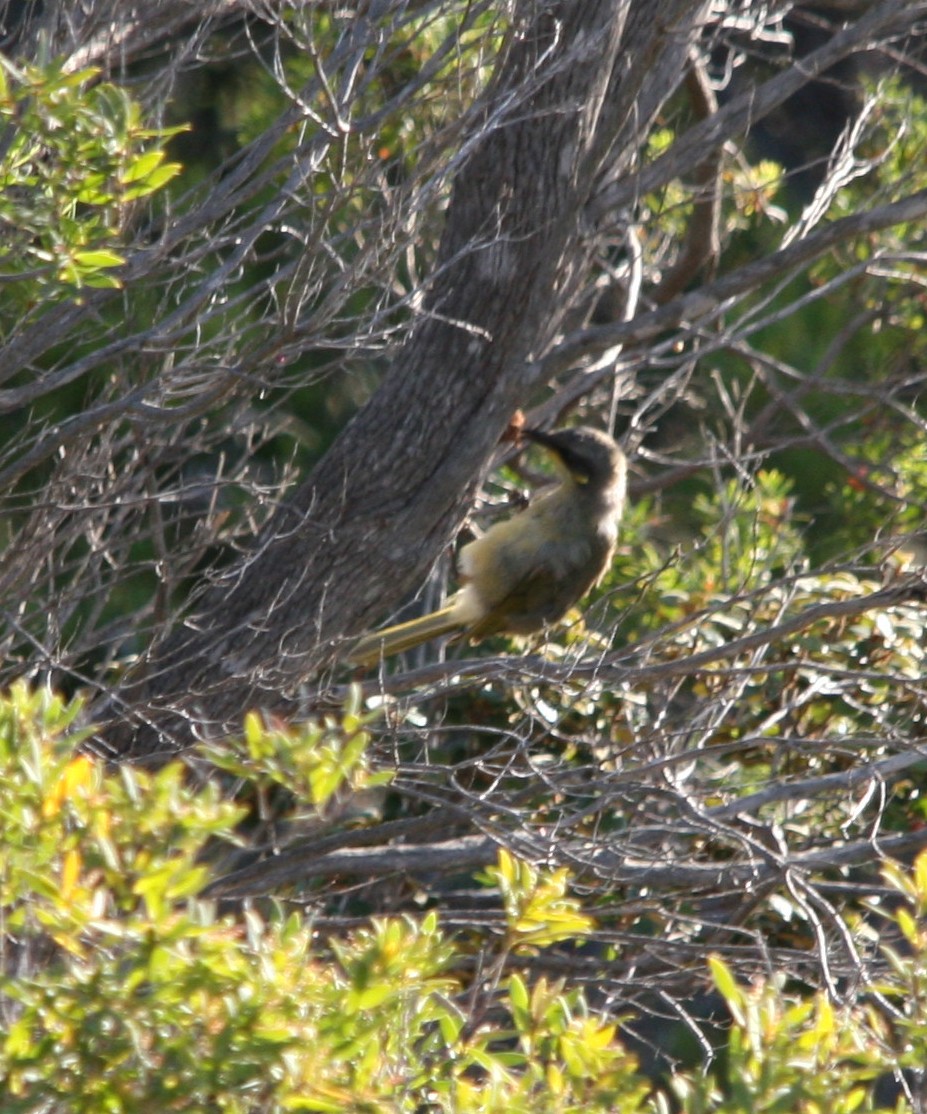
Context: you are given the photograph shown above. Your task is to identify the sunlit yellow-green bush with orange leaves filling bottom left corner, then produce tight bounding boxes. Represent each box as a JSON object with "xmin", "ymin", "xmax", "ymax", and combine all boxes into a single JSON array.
[{"xmin": 0, "ymin": 686, "xmax": 645, "ymax": 1114}]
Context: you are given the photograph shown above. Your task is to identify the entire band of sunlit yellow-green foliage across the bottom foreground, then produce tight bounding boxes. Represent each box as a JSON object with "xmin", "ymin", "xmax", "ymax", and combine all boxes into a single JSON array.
[{"xmin": 0, "ymin": 685, "xmax": 927, "ymax": 1114}]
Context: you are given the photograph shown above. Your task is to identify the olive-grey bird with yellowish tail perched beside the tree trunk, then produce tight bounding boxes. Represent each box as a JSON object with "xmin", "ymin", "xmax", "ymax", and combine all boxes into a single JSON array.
[{"xmin": 348, "ymin": 426, "xmax": 627, "ymax": 667}]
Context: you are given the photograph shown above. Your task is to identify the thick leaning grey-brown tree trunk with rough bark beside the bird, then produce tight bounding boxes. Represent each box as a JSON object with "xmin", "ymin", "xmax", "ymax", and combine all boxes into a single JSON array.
[{"xmin": 99, "ymin": 0, "xmax": 704, "ymax": 756}]
